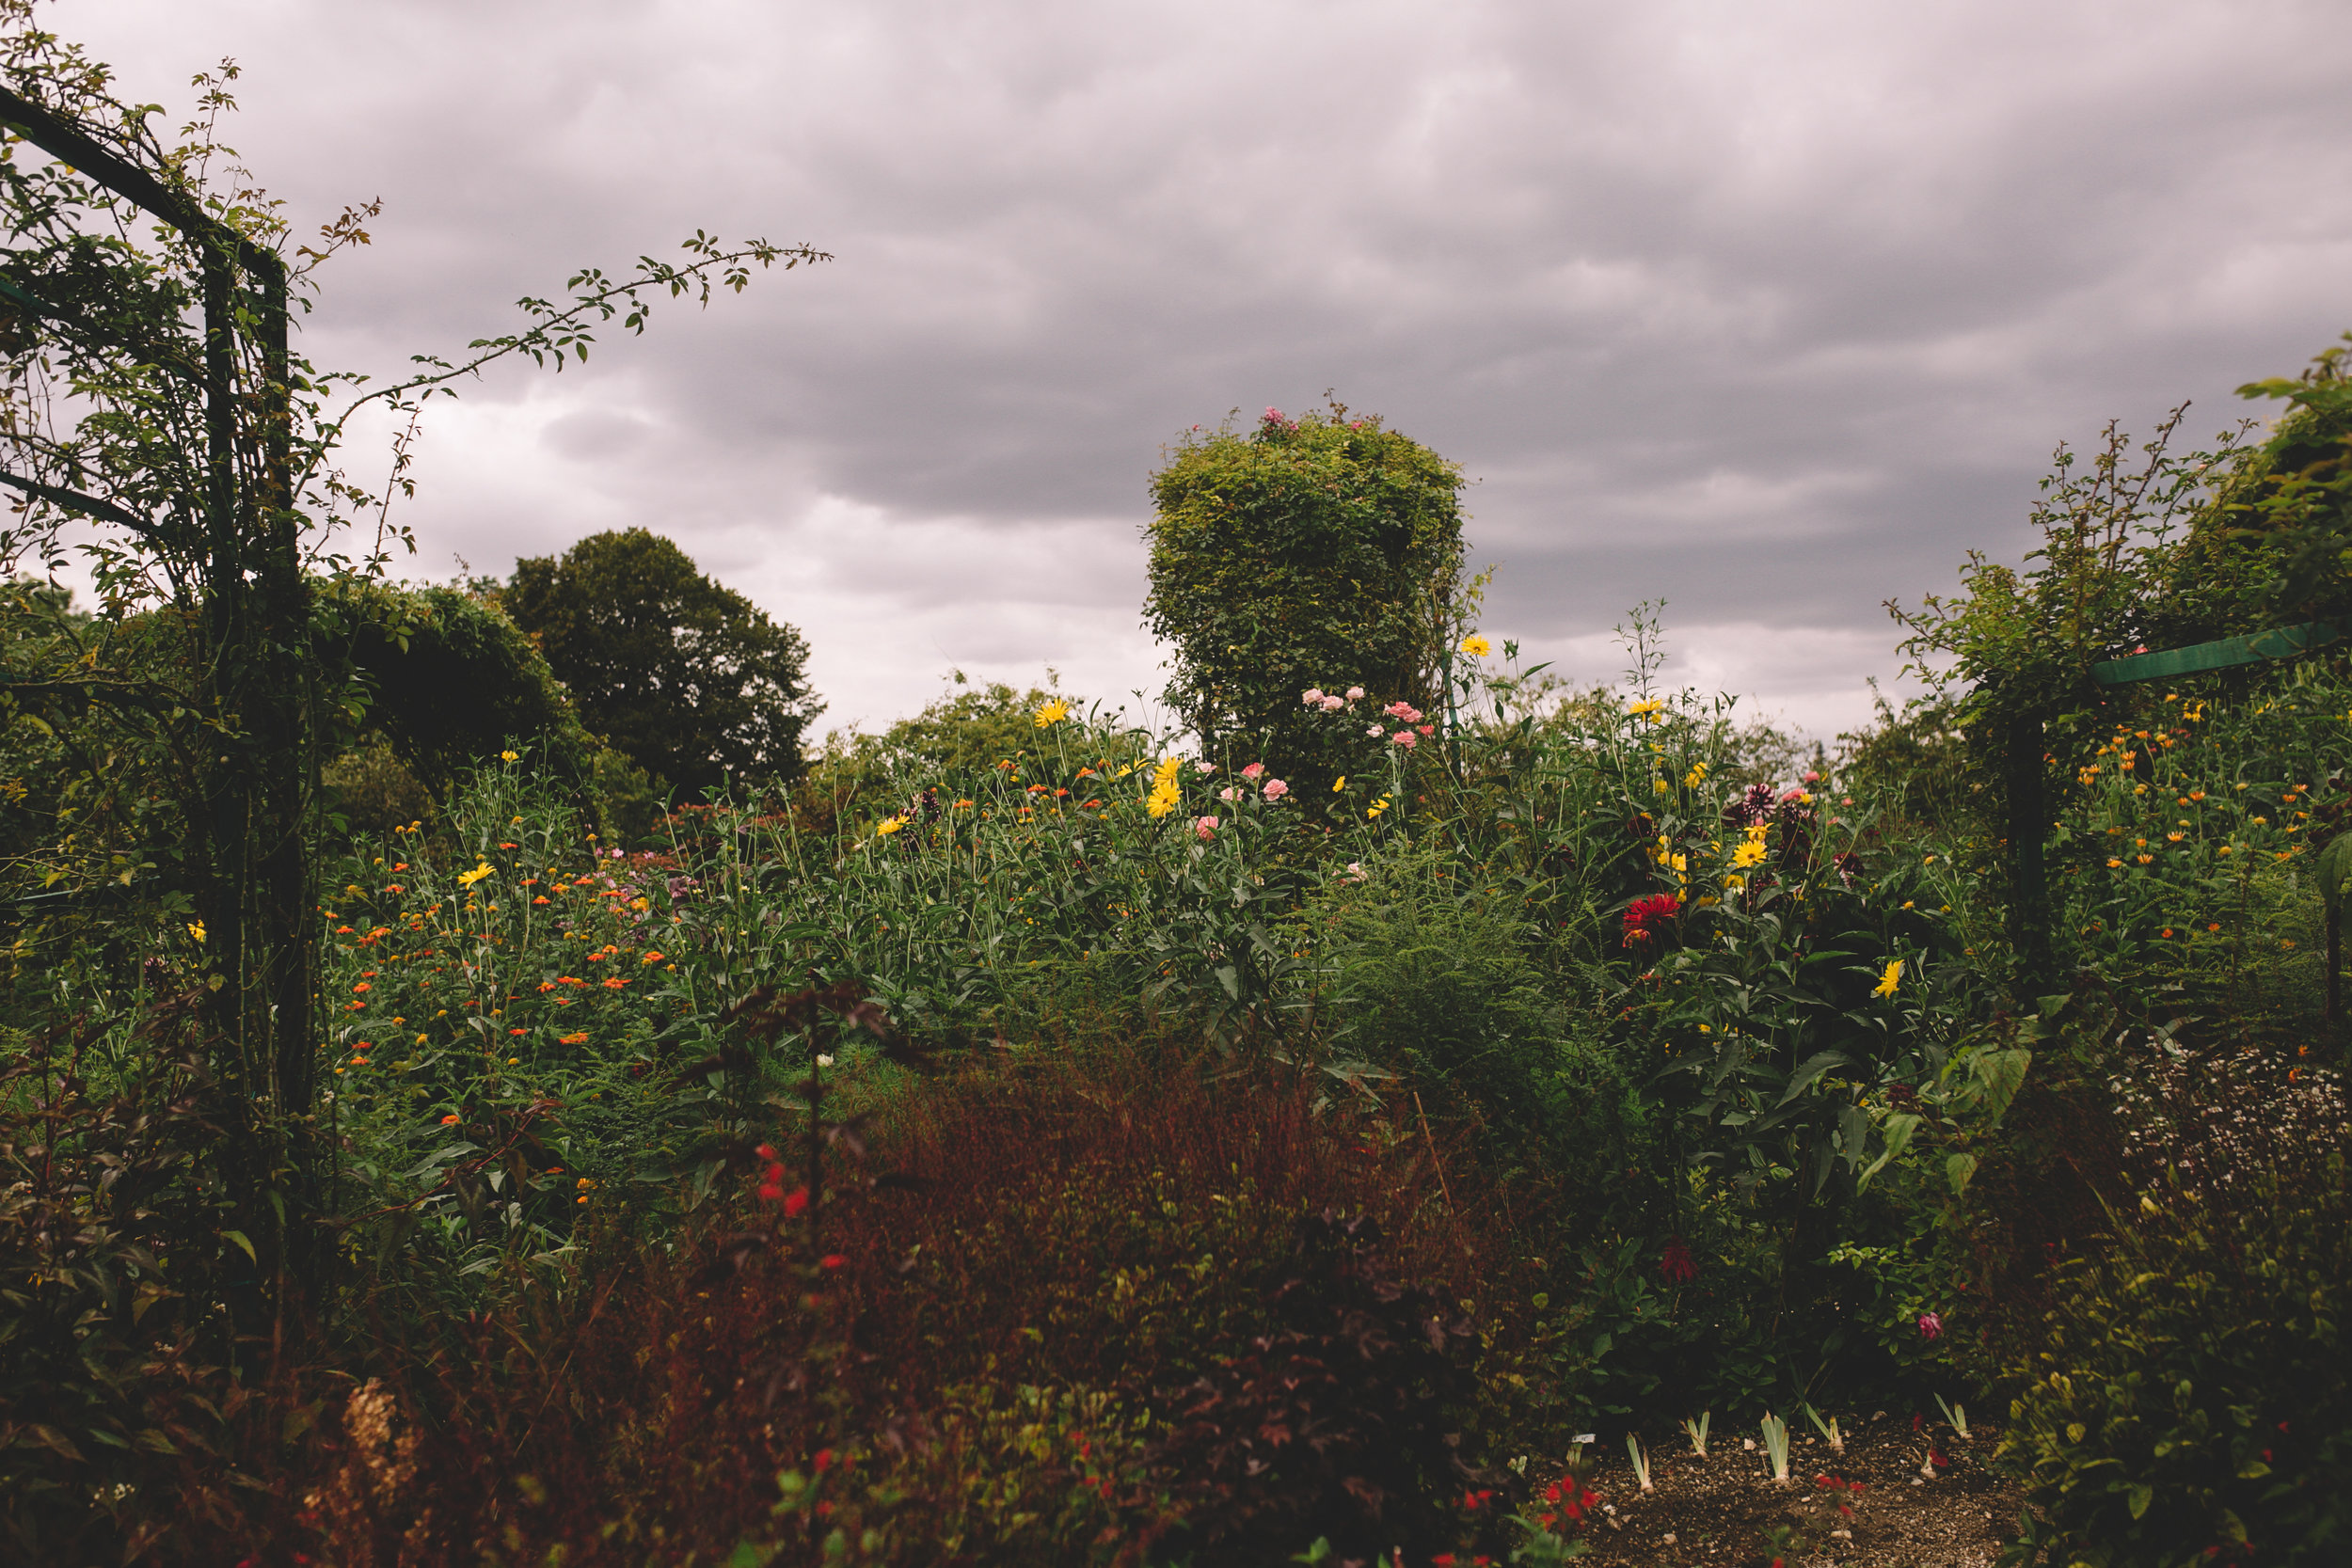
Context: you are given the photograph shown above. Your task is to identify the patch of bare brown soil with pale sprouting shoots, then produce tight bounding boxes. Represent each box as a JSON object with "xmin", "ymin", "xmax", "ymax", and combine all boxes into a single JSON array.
[{"xmin": 1583, "ymin": 1416, "xmax": 2023, "ymax": 1568}]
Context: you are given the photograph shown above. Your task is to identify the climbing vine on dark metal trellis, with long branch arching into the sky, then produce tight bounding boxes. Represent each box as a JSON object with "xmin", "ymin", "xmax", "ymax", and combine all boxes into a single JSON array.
[{"xmin": 0, "ymin": 15, "xmax": 821, "ymax": 1331}]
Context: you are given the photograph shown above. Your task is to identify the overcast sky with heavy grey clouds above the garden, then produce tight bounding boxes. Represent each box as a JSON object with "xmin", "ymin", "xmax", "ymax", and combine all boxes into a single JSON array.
[{"xmin": 45, "ymin": 0, "xmax": 2352, "ymax": 734}]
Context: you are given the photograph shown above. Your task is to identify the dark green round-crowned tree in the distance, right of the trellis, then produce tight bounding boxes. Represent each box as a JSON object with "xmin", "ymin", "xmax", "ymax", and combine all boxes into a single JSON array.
[{"xmin": 501, "ymin": 529, "xmax": 823, "ymax": 797}]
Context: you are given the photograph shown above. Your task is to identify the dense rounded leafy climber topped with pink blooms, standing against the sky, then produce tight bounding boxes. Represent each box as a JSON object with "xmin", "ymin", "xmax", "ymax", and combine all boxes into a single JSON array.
[{"xmin": 1143, "ymin": 404, "xmax": 1463, "ymax": 776}]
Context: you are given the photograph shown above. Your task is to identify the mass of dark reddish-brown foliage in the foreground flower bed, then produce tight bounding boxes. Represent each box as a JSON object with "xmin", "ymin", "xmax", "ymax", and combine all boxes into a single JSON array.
[{"xmin": 270, "ymin": 1051, "xmax": 1543, "ymax": 1568}]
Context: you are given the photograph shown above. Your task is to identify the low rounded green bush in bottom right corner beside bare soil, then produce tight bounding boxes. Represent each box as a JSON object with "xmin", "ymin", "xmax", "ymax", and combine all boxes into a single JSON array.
[{"xmin": 2007, "ymin": 1152, "xmax": 2352, "ymax": 1568}]
